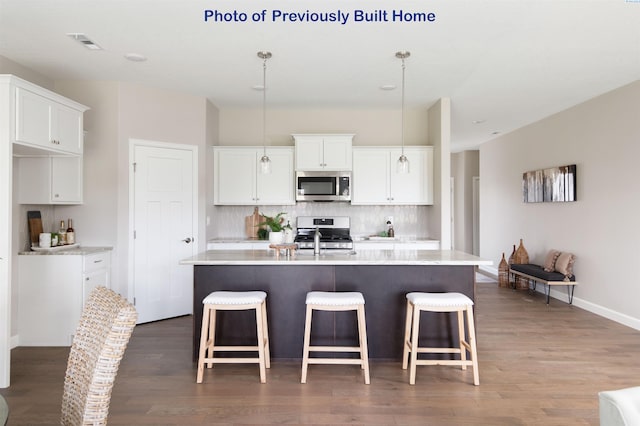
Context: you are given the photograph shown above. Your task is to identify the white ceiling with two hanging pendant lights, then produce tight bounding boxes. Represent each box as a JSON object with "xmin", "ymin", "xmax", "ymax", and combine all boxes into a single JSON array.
[{"xmin": 0, "ymin": 0, "xmax": 640, "ymax": 150}]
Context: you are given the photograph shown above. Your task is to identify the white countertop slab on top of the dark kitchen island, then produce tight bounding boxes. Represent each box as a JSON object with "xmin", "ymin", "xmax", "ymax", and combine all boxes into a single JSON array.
[{"xmin": 180, "ymin": 250, "xmax": 493, "ymax": 266}]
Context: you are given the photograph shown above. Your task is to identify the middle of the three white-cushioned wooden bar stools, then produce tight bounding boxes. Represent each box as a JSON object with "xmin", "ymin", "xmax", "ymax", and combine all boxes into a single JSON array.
[{"xmin": 301, "ymin": 291, "xmax": 370, "ymax": 385}]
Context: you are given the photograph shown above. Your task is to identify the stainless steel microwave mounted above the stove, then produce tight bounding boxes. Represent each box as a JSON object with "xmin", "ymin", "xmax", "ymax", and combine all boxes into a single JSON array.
[{"xmin": 296, "ymin": 172, "xmax": 351, "ymax": 201}]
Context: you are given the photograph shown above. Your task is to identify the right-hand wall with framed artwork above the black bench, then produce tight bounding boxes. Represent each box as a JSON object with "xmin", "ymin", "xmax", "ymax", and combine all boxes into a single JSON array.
[{"xmin": 480, "ymin": 82, "xmax": 640, "ymax": 329}]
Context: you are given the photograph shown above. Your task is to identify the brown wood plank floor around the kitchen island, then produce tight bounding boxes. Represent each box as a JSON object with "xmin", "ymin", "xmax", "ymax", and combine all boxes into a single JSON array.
[{"xmin": 0, "ymin": 282, "xmax": 640, "ymax": 426}]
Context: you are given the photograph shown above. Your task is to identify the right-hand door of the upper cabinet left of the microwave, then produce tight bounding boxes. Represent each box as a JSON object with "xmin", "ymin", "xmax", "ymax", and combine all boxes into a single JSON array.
[{"xmin": 255, "ymin": 148, "xmax": 296, "ymax": 205}]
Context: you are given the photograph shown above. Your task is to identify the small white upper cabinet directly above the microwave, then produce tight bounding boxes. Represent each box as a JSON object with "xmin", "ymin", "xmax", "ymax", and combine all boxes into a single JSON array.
[{"xmin": 293, "ymin": 134, "xmax": 354, "ymax": 171}]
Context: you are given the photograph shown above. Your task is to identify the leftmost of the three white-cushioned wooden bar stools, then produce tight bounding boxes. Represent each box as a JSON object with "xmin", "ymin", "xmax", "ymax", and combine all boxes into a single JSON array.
[{"xmin": 196, "ymin": 291, "xmax": 271, "ymax": 383}]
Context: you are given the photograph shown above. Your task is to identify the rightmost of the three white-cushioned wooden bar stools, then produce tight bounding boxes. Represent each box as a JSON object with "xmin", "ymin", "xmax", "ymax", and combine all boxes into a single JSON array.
[{"xmin": 402, "ymin": 292, "xmax": 480, "ymax": 386}]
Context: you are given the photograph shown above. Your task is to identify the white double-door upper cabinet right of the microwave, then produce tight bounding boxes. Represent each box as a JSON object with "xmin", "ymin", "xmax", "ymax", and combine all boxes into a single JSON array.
[{"xmin": 351, "ymin": 146, "xmax": 433, "ymax": 205}]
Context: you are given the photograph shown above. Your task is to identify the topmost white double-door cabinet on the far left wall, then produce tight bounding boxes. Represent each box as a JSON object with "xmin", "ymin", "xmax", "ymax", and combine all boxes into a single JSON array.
[{"xmin": 15, "ymin": 87, "xmax": 84, "ymax": 154}]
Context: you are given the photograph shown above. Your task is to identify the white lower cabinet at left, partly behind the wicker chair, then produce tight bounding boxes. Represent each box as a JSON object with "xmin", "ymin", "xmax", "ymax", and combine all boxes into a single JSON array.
[{"xmin": 18, "ymin": 251, "xmax": 111, "ymax": 346}]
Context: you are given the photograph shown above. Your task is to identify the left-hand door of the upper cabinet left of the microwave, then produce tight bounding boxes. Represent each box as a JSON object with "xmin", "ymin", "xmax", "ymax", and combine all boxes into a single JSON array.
[{"xmin": 213, "ymin": 148, "xmax": 257, "ymax": 205}]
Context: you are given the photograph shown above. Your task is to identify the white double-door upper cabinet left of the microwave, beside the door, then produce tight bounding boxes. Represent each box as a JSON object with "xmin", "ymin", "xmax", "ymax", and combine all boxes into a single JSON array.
[{"xmin": 213, "ymin": 147, "xmax": 295, "ymax": 205}]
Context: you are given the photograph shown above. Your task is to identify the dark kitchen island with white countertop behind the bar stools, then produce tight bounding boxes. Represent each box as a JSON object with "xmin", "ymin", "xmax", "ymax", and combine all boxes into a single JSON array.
[{"xmin": 181, "ymin": 250, "xmax": 492, "ymax": 360}]
